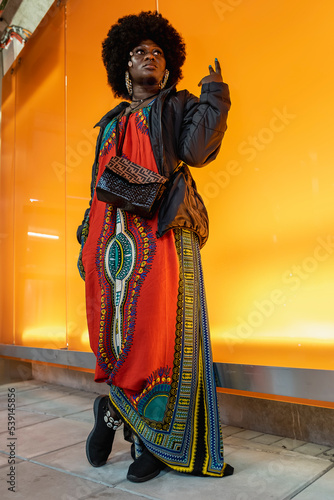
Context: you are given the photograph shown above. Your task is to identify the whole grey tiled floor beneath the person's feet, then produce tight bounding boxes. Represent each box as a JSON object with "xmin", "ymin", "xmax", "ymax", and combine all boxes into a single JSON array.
[{"xmin": 0, "ymin": 381, "xmax": 334, "ymax": 500}]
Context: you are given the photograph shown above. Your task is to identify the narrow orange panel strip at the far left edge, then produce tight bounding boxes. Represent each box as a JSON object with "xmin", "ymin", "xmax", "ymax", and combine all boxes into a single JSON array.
[{"xmin": 0, "ymin": 65, "xmax": 15, "ymax": 344}]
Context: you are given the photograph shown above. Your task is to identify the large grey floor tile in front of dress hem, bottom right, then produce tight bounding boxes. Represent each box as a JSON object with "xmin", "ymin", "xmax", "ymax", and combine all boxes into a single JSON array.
[{"xmin": 118, "ymin": 447, "xmax": 329, "ymax": 500}]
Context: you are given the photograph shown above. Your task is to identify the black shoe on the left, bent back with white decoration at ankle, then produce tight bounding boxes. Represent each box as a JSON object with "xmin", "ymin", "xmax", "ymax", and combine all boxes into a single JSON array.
[{"xmin": 86, "ymin": 396, "xmax": 121, "ymax": 467}]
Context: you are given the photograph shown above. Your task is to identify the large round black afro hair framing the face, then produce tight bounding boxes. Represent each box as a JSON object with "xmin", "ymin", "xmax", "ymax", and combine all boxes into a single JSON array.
[{"xmin": 102, "ymin": 11, "xmax": 186, "ymax": 100}]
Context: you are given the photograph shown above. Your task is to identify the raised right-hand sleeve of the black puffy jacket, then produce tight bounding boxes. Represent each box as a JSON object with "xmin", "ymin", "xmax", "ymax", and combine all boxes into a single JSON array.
[{"xmin": 178, "ymin": 82, "xmax": 231, "ymax": 167}]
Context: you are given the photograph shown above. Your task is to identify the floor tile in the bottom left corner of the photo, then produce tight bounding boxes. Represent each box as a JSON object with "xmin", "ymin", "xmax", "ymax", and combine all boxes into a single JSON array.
[{"xmin": 0, "ymin": 462, "xmax": 105, "ymax": 500}]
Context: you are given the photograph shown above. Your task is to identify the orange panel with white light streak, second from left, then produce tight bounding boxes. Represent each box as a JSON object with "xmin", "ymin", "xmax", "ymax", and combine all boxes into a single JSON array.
[{"xmin": 14, "ymin": 6, "xmax": 66, "ymax": 348}]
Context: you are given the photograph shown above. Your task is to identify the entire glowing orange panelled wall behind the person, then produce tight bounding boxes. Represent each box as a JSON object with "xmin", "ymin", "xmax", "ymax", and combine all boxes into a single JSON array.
[{"xmin": 0, "ymin": 0, "xmax": 334, "ymax": 369}]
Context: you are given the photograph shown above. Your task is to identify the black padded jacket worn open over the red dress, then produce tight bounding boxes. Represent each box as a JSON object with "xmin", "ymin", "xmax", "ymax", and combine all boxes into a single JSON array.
[{"xmin": 77, "ymin": 82, "xmax": 231, "ymax": 247}]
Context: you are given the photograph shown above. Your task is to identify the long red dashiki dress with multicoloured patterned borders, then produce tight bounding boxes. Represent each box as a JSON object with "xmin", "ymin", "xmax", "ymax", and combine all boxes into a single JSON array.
[{"xmin": 79, "ymin": 106, "xmax": 228, "ymax": 476}]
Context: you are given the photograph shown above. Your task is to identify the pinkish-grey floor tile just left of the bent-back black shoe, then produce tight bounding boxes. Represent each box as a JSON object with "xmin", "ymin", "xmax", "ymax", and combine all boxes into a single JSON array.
[{"xmin": 16, "ymin": 418, "xmax": 91, "ymax": 458}]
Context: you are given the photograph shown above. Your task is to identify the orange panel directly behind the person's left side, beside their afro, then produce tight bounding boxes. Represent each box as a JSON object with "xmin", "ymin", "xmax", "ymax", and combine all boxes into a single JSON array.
[{"xmin": 66, "ymin": 0, "xmax": 155, "ymax": 351}]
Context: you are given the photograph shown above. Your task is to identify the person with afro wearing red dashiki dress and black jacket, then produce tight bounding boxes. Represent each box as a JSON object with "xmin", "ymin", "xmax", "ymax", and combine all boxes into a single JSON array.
[{"xmin": 78, "ymin": 12, "xmax": 233, "ymax": 482}]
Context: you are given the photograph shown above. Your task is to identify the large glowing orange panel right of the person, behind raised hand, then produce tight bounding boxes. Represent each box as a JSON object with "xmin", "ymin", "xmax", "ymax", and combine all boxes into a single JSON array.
[{"xmin": 159, "ymin": 0, "xmax": 334, "ymax": 369}]
